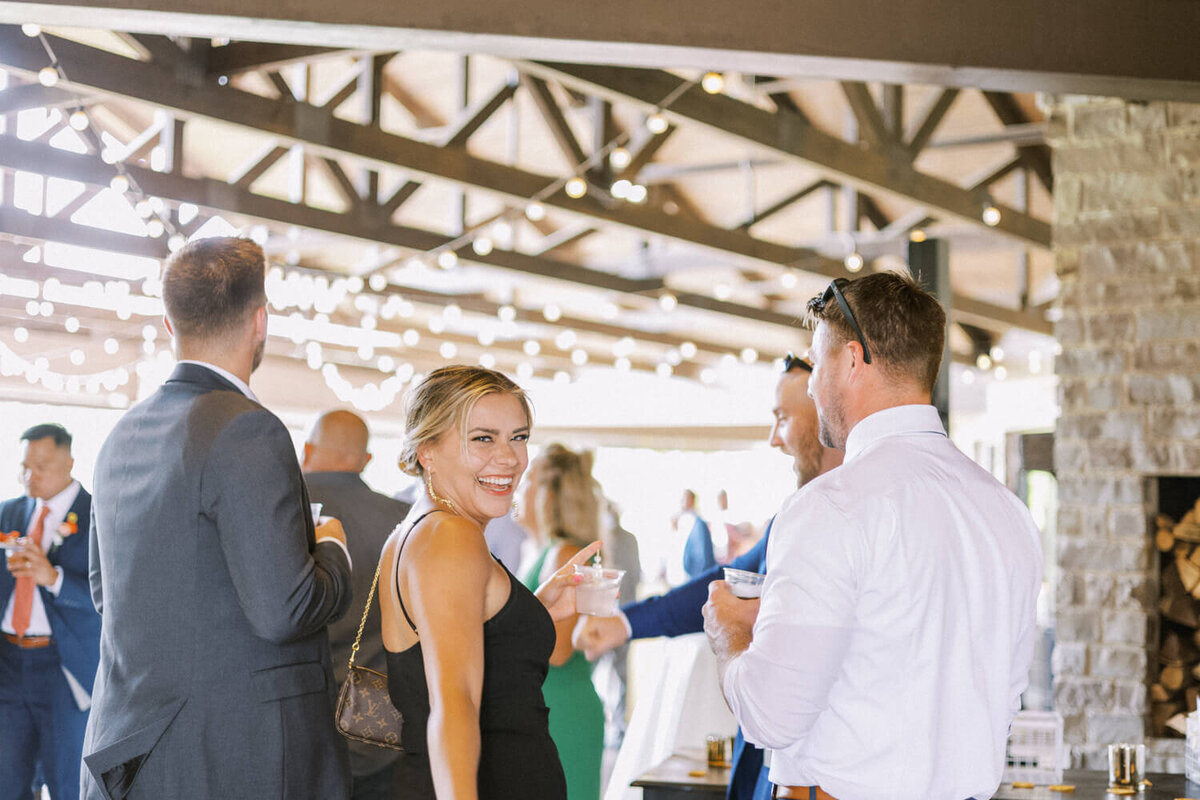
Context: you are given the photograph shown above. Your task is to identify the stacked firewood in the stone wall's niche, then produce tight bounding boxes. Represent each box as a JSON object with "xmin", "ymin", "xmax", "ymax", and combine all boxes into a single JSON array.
[{"xmin": 1150, "ymin": 510, "xmax": 1200, "ymax": 736}]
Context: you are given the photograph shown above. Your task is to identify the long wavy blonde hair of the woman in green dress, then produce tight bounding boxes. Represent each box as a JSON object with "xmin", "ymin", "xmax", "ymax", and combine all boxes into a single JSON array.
[{"xmin": 529, "ymin": 443, "xmax": 600, "ymax": 546}]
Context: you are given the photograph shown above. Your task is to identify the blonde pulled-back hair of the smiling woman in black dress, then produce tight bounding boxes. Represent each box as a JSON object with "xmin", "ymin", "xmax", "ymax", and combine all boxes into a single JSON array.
[{"xmin": 400, "ymin": 365, "xmax": 533, "ymax": 477}]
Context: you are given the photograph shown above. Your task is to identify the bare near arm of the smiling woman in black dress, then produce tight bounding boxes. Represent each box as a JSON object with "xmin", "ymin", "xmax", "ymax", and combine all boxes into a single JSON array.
[{"xmin": 401, "ymin": 515, "xmax": 493, "ymax": 800}]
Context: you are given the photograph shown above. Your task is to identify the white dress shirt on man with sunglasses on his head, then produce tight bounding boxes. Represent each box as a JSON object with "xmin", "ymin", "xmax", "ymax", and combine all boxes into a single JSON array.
[{"xmin": 725, "ymin": 405, "xmax": 1042, "ymax": 800}]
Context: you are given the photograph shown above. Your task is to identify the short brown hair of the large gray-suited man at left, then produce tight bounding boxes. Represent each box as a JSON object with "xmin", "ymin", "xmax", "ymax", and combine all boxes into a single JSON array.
[{"xmin": 162, "ymin": 236, "xmax": 266, "ymax": 339}]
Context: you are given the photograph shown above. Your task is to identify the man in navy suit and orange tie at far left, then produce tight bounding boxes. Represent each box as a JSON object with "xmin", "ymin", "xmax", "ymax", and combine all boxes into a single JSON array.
[{"xmin": 0, "ymin": 425, "xmax": 100, "ymax": 800}]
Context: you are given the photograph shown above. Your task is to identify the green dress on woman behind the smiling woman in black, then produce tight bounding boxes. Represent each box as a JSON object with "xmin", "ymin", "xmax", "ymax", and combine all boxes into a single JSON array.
[{"xmin": 523, "ymin": 547, "xmax": 604, "ymax": 800}]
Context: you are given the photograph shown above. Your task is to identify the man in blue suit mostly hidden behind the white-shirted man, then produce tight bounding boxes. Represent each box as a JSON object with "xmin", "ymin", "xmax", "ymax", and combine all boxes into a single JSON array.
[{"xmin": 574, "ymin": 354, "xmax": 842, "ymax": 800}]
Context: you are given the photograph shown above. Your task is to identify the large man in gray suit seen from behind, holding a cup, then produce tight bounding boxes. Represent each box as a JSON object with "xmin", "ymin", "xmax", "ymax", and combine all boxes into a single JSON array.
[{"xmin": 80, "ymin": 239, "xmax": 350, "ymax": 800}]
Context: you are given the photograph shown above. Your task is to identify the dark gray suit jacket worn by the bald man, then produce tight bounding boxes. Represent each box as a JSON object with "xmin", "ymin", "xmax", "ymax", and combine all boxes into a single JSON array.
[{"xmin": 304, "ymin": 473, "xmax": 409, "ymax": 776}]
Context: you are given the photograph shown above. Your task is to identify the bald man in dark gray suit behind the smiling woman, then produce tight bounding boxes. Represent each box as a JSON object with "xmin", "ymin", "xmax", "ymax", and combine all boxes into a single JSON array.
[{"xmin": 301, "ymin": 410, "xmax": 409, "ymax": 800}]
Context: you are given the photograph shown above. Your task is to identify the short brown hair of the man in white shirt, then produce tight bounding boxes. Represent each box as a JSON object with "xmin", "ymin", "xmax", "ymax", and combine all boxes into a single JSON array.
[{"xmin": 805, "ymin": 272, "xmax": 946, "ymax": 391}]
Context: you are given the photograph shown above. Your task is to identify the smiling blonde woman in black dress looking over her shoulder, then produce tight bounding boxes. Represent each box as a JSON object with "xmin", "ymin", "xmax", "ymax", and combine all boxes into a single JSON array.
[{"xmin": 379, "ymin": 366, "xmax": 599, "ymax": 800}]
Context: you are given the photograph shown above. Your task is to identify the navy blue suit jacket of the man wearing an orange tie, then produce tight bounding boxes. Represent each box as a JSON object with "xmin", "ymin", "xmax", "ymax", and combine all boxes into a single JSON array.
[{"xmin": 0, "ymin": 487, "xmax": 100, "ymax": 693}]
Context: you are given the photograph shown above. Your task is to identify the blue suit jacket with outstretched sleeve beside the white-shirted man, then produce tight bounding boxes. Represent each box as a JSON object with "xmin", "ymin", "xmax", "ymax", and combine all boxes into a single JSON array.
[{"xmin": 620, "ymin": 517, "xmax": 775, "ymax": 800}]
